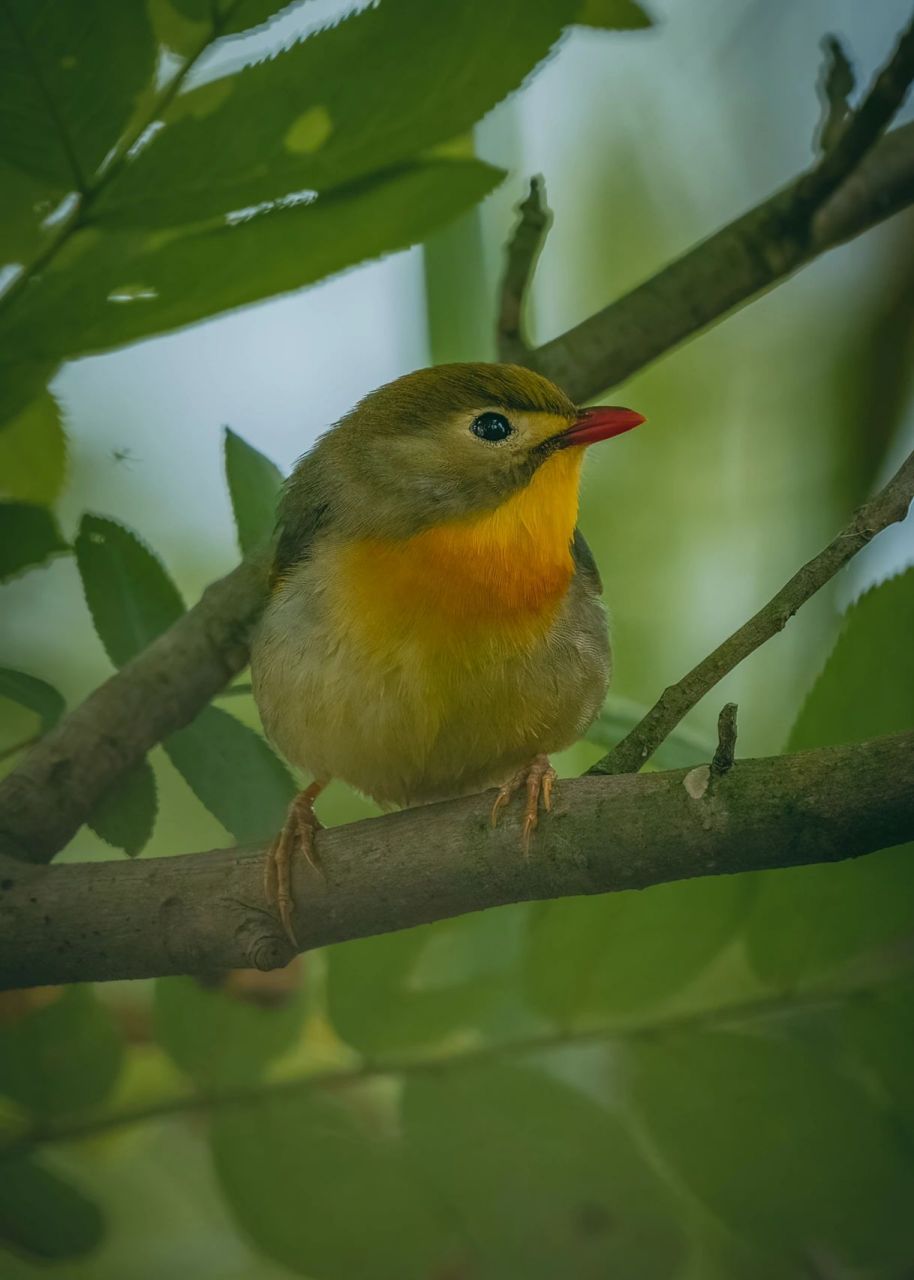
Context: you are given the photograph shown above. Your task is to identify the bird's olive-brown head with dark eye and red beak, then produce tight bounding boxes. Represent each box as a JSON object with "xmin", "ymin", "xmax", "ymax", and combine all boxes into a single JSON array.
[{"xmin": 313, "ymin": 364, "xmax": 644, "ymax": 538}]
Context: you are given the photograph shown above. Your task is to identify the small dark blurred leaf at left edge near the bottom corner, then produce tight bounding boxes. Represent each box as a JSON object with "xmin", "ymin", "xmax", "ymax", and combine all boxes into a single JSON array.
[{"xmin": 0, "ymin": 1156, "xmax": 104, "ymax": 1262}]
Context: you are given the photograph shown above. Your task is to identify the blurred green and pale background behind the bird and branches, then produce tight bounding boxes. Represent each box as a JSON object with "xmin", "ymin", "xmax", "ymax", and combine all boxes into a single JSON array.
[{"xmin": 0, "ymin": 0, "xmax": 914, "ymax": 1280}]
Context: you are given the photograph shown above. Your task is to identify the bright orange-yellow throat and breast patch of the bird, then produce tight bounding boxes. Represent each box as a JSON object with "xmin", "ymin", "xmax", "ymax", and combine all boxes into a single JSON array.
[{"xmin": 338, "ymin": 449, "xmax": 584, "ymax": 649}]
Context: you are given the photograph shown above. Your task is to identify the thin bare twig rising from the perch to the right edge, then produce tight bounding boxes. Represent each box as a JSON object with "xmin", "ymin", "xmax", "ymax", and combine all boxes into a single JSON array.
[{"xmin": 588, "ymin": 453, "xmax": 914, "ymax": 773}]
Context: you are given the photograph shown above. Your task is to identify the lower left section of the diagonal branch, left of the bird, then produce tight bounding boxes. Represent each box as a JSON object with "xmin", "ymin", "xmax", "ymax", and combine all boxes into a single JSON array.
[{"xmin": 0, "ymin": 562, "xmax": 265, "ymax": 863}]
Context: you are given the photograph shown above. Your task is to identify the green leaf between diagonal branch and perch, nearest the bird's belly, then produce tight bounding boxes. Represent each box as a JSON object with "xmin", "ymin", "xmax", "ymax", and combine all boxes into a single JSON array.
[{"xmin": 164, "ymin": 707, "xmax": 296, "ymax": 844}]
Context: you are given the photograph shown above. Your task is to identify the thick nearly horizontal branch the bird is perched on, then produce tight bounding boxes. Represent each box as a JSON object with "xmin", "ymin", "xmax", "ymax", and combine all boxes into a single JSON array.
[{"xmin": 0, "ymin": 733, "xmax": 914, "ymax": 987}]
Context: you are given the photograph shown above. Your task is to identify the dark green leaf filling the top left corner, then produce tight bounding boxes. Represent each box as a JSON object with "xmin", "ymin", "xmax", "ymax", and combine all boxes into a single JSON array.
[{"xmin": 0, "ymin": 0, "xmax": 156, "ymax": 191}]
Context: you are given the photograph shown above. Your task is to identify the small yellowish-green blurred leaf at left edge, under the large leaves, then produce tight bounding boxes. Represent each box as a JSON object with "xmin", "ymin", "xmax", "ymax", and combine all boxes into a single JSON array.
[{"xmin": 0, "ymin": 390, "xmax": 67, "ymax": 506}]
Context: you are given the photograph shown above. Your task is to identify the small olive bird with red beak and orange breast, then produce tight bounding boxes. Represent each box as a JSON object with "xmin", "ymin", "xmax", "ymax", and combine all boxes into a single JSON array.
[{"xmin": 251, "ymin": 362, "xmax": 644, "ymax": 947}]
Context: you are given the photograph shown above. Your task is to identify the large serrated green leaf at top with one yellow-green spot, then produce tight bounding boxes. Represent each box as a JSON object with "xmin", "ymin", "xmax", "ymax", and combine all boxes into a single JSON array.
[{"xmin": 92, "ymin": 0, "xmax": 577, "ymax": 227}]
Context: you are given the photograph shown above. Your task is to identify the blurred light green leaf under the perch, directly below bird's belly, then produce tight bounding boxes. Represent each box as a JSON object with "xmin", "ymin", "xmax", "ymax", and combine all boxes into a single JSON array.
[{"xmin": 326, "ymin": 906, "xmax": 527, "ymax": 1057}]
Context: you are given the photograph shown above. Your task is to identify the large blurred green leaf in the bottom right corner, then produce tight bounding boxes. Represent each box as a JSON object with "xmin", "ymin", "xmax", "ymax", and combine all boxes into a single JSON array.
[{"xmin": 629, "ymin": 1033, "xmax": 914, "ymax": 1275}]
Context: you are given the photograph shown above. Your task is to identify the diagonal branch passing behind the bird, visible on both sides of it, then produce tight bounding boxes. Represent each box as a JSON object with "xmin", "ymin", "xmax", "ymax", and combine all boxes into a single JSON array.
[{"xmin": 0, "ymin": 45, "xmax": 914, "ymax": 861}]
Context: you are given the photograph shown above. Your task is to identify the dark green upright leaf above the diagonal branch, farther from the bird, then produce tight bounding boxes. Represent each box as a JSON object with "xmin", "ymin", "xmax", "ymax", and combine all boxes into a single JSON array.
[{"xmin": 76, "ymin": 515, "xmax": 184, "ymax": 667}]
